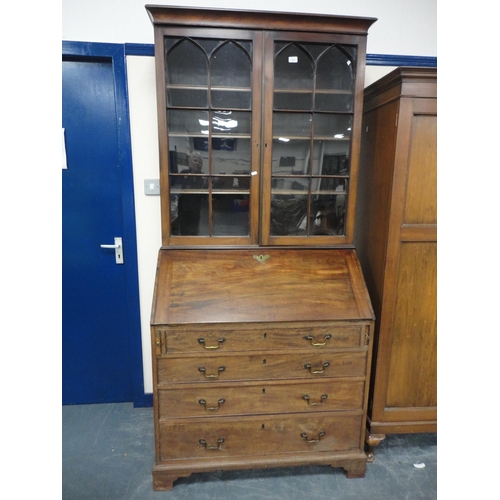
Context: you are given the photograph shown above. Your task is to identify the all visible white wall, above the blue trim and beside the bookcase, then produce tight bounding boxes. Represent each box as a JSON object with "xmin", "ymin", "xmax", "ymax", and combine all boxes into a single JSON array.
[{"xmin": 62, "ymin": 0, "xmax": 437, "ymax": 393}]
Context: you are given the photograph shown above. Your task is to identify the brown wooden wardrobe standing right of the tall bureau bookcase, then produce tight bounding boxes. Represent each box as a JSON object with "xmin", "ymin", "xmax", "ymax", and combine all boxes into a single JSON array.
[{"xmin": 355, "ymin": 67, "xmax": 437, "ymax": 459}]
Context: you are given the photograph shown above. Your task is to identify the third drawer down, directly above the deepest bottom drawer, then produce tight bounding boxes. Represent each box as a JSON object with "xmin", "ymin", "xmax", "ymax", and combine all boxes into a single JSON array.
[{"xmin": 158, "ymin": 379, "xmax": 364, "ymax": 420}]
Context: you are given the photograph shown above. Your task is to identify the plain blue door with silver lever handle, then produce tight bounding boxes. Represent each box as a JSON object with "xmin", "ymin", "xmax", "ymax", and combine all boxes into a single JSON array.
[{"xmin": 62, "ymin": 44, "xmax": 144, "ymax": 405}]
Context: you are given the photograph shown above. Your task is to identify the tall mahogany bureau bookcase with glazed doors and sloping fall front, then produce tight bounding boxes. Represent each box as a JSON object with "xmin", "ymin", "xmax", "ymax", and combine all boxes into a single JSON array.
[{"xmin": 146, "ymin": 5, "xmax": 375, "ymax": 490}]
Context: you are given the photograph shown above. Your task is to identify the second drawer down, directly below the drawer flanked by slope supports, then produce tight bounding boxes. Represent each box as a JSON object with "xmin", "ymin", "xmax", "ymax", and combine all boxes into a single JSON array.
[{"xmin": 157, "ymin": 351, "xmax": 366, "ymax": 384}]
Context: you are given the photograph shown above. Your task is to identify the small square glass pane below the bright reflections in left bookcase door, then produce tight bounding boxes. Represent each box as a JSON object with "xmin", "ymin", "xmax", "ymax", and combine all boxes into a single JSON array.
[{"xmin": 212, "ymin": 137, "xmax": 251, "ymax": 175}]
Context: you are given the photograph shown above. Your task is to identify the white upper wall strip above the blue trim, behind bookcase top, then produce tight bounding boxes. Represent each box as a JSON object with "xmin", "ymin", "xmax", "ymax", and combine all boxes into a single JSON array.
[{"xmin": 62, "ymin": 0, "xmax": 437, "ymax": 56}]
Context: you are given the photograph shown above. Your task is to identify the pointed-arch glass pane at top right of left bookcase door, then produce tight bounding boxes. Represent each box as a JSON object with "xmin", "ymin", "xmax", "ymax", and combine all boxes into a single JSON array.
[{"xmin": 210, "ymin": 42, "xmax": 252, "ymax": 89}]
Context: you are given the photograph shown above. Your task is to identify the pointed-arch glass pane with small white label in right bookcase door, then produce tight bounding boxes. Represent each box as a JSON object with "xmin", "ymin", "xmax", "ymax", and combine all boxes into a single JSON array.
[{"xmin": 274, "ymin": 43, "xmax": 314, "ymax": 91}]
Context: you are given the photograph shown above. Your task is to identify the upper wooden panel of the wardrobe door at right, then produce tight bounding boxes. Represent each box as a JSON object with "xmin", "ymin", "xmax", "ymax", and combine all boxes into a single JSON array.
[{"xmin": 404, "ymin": 115, "xmax": 437, "ymax": 224}]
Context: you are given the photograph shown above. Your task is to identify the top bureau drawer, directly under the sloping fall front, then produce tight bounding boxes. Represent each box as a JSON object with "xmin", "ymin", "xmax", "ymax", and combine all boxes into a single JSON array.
[{"xmin": 156, "ymin": 324, "xmax": 366, "ymax": 355}]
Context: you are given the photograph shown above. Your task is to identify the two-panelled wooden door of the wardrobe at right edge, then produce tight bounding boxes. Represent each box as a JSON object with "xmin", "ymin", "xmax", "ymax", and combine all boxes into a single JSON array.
[{"xmin": 372, "ymin": 99, "xmax": 437, "ymax": 431}]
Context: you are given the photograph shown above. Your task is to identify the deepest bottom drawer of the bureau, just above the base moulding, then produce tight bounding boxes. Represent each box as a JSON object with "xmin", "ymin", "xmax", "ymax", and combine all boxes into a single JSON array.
[{"xmin": 160, "ymin": 413, "xmax": 362, "ymax": 461}]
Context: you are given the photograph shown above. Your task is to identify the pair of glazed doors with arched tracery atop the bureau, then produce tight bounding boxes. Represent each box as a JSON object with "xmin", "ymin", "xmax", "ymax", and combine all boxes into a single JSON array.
[{"xmin": 156, "ymin": 27, "xmax": 366, "ymax": 246}]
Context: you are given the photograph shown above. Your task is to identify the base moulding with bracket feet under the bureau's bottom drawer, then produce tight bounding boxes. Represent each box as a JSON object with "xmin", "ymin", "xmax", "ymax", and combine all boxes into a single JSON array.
[{"xmin": 152, "ymin": 453, "xmax": 367, "ymax": 491}]
